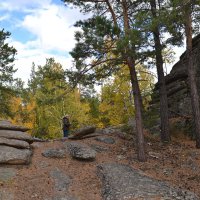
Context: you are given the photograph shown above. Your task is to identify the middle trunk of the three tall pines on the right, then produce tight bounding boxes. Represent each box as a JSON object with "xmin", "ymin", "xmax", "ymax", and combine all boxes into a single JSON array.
[{"xmin": 150, "ymin": 0, "xmax": 170, "ymax": 142}]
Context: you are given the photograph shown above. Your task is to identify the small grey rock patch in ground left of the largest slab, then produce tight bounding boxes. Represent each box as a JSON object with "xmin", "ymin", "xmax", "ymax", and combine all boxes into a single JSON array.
[{"xmin": 50, "ymin": 168, "xmax": 72, "ymax": 192}]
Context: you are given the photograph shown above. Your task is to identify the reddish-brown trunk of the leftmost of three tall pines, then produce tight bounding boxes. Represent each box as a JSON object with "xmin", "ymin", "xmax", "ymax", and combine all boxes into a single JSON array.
[{"xmin": 122, "ymin": 0, "xmax": 147, "ymax": 162}]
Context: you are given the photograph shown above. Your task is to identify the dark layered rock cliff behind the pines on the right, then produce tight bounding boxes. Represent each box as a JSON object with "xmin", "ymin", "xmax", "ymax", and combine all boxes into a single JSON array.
[{"xmin": 152, "ymin": 34, "xmax": 200, "ymax": 118}]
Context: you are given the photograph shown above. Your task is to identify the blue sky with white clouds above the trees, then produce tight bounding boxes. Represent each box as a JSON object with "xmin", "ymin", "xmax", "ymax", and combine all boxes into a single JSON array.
[{"xmin": 0, "ymin": 0, "xmax": 183, "ymax": 83}]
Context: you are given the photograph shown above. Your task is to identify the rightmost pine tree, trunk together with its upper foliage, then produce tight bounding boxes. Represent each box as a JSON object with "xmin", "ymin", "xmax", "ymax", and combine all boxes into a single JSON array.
[{"xmin": 171, "ymin": 0, "xmax": 200, "ymax": 148}]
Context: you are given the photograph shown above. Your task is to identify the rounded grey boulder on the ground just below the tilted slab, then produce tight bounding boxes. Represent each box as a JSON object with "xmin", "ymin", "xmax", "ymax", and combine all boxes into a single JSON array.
[{"xmin": 67, "ymin": 142, "xmax": 96, "ymax": 161}]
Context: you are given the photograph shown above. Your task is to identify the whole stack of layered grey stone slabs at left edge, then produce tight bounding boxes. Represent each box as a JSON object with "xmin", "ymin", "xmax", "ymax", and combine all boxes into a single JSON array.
[{"xmin": 0, "ymin": 120, "xmax": 33, "ymax": 165}]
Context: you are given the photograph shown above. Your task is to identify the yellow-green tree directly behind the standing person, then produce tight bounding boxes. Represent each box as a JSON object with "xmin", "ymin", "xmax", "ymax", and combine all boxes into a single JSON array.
[{"xmin": 29, "ymin": 58, "xmax": 89, "ymax": 138}]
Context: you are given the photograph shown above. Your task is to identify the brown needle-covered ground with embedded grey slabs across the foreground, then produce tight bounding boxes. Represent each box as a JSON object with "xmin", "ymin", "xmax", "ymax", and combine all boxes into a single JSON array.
[{"xmin": 0, "ymin": 133, "xmax": 200, "ymax": 200}]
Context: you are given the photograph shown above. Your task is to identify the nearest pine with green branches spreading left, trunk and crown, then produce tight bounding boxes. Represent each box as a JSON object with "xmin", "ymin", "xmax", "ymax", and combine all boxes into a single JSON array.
[{"xmin": 65, "ymin": 0, "xmax": 146, "ymax": 161}]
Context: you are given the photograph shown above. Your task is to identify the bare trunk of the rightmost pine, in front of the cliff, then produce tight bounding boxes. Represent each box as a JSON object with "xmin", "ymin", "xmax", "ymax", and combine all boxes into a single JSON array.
[{"xmin": 185, "ymin": 4, "xmax": 200, "ymax": 148}]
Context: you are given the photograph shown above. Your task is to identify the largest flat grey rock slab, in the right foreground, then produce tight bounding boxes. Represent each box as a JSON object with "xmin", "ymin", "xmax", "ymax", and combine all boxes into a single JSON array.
[{"xmin": 97, "ymin": 163, "xmax": 199, "ymax": 200}]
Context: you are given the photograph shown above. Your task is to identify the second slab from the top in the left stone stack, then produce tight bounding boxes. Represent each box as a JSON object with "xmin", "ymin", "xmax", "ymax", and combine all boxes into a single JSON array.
[{"xmin": 0, "ymin": 130, "xmax": 33, "ymax": 143}]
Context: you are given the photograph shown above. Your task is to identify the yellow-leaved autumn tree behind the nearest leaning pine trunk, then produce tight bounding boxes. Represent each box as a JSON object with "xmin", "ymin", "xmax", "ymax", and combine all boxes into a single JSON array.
[{"xmin": 99, "ymin": 65, "xmax": 154, "ymax": 126}]
